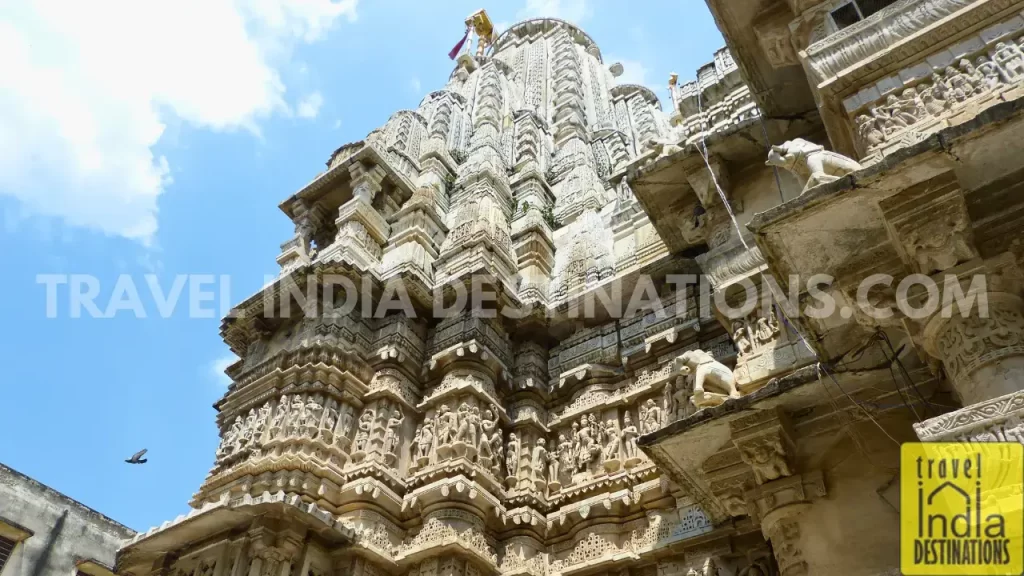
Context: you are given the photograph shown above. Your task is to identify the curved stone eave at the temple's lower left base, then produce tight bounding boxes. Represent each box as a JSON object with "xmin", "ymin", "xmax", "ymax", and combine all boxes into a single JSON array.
[{"xmin": 116, "ymin": 492, "xmax": 354, "ymax": 574}]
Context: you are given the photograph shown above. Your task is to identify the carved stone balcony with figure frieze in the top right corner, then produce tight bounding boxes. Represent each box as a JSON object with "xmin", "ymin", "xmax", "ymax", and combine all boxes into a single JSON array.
[{"xmin": 801, "ymin": 0, "xmax": 1024, "ymax": 158}]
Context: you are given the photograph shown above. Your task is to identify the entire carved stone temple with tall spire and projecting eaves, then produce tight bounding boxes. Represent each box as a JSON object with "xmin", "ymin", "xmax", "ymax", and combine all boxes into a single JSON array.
[{"xmin": 116, "ymin": 0, "xmax": 1024, "ymax": 576}]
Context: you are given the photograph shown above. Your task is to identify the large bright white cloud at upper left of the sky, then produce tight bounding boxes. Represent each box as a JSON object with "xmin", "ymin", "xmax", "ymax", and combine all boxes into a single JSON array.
[{"xmin": 0, "ymin": 0, "xmax": 357, "ymax": 244}]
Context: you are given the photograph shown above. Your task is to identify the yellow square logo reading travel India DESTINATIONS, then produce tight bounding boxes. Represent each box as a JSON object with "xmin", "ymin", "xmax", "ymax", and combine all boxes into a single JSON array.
[{"xmin": 900, "ymin": 442, "xmax": 1024, "ymax": 576}]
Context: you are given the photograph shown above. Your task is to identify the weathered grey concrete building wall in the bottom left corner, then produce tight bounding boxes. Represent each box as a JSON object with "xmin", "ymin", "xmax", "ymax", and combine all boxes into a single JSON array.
[{"xmin": 0, "ymin": 464, "xmax": 134, "ymax": 576}]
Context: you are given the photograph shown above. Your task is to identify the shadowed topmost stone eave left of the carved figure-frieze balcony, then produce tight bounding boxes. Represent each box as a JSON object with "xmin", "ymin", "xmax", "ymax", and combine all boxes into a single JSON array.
[{"xmin": 705, "ymin": 0, "xmax": 815, "ymax": 117}]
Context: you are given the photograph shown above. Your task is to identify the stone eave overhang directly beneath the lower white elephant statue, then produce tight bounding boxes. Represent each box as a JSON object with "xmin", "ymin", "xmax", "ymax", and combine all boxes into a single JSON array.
[{"xmin": 638, "ymin": 364, "xmax": 938, "ymax": 526}]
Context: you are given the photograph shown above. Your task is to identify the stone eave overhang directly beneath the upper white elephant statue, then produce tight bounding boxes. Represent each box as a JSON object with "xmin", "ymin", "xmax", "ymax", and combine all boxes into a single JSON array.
[{"xmin": 748, "ymin": 98, "xmax": 1024, "ymax": 358}]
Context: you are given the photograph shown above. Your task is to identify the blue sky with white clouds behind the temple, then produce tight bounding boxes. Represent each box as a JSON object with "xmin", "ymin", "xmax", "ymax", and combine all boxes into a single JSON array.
[{"xmin": 0, "ymin": 0, "xmax": 723, "ymax": 530}]
